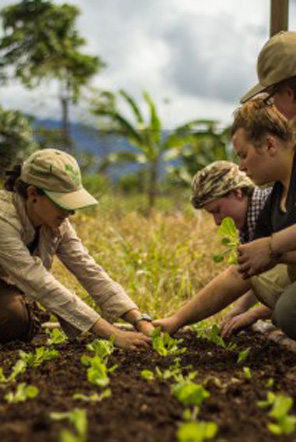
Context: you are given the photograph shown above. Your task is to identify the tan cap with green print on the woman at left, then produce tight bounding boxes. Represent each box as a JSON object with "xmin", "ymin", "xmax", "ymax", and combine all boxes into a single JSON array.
[{"xmin": 20, "ymin": 149, "xmax": 98, "ymax": 210}]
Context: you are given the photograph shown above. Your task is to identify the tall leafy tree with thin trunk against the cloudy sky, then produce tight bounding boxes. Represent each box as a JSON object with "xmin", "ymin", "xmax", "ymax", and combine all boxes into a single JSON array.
[{"xmin": 0, "ymin": 0, "xmax": 103, "ymax": 149}]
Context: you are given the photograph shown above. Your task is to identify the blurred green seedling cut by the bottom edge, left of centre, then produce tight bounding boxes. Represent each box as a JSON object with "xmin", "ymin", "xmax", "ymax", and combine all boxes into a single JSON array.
[{"xmin": 50, "ymin": 408, "xmax": 87, "ymax": 442}]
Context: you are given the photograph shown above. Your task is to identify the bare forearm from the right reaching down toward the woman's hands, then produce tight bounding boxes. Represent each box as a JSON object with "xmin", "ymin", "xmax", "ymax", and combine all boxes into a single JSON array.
[{"xmin": 173, "ymin": 267, "xmax": 250, "ymax": 328}]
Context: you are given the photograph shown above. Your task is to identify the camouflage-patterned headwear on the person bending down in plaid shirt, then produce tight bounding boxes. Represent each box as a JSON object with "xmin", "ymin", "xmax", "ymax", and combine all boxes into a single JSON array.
[{"xmin": 191, "ymin": 161, "xmax": 254, "ymax": 209}]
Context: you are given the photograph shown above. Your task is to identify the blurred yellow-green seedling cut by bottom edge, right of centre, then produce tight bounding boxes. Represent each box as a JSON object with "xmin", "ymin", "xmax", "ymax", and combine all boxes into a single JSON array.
[{"xmin": 177, "ymin": 421, "xmax": 218, "ymax": 442}]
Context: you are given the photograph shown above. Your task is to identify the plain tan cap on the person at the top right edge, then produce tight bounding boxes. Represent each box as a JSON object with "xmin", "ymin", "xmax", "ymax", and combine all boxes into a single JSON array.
[{"xmin": 241, "ymin": 31, "xmax": 296, "ymax": 103}]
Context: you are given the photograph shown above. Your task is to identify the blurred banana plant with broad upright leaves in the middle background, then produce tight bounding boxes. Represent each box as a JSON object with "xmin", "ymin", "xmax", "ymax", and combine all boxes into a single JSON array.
[{"xmin": 92, "ymin": 90, "xmax": 190, "ymax": 212}]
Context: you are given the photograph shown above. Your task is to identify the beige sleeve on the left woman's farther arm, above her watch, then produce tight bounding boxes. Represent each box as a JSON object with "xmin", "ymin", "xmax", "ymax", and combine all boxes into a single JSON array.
[{"xmin": 57, "ymin": 220, "xmax": 138, "ymax": 322}]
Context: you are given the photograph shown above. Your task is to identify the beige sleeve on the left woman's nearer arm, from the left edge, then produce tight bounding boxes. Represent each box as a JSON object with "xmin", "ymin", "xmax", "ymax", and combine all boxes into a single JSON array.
[{"xmin": 0, "ymin": 219, "xmax": 100, "ymax": 332}]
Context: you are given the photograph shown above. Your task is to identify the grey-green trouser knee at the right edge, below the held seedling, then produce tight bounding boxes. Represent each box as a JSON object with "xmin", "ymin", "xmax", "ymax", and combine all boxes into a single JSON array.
[{"xmin": 272, "ymin": 282, "xmax": 296, "ymax": 340}]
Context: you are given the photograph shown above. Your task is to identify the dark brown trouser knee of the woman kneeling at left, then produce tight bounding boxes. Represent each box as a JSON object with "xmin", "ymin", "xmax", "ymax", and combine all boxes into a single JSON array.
[{"xmin": 0, "ymin": 280, "xmax": 40, "ymax": 344}]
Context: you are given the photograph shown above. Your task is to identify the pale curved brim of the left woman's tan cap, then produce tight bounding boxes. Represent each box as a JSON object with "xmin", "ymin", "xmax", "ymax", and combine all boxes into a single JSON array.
[{"xmin": 43, "ymin": 188, "xmax": 98, "ymax": 210}]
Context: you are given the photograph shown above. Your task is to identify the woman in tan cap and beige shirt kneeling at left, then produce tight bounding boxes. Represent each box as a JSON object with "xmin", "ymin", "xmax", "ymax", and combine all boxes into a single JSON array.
[{"xmin": 0, "ymin": 149, "xmax": 153, "ymax": 349}]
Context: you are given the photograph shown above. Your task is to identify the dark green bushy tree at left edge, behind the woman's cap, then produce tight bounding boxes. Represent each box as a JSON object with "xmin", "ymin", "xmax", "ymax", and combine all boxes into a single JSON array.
[{"xmin": 0, "ymin": 106, "xmax": 38, "ymax": 175}]
